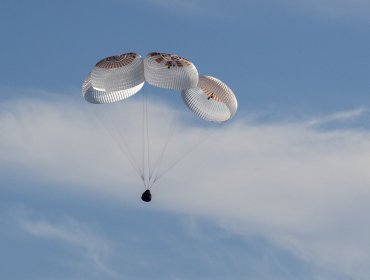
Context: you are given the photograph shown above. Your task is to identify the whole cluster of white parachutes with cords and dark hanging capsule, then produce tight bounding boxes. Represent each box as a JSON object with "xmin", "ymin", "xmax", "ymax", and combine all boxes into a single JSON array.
[{"xmin": 82, "ymin": 52, "xmax": 237, "ymax": 202}]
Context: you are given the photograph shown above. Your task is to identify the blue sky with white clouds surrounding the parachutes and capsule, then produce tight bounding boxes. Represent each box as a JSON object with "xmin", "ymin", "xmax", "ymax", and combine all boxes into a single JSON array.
[{"xmin": 0, "ymin": 0, "xmax": 370, "ymax": 280}]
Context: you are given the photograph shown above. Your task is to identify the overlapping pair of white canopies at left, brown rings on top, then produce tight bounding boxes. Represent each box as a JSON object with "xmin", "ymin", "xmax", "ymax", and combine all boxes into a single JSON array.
[{"xmin": 82, "ymin": 53, "xmax": 145, "ymax": 104}]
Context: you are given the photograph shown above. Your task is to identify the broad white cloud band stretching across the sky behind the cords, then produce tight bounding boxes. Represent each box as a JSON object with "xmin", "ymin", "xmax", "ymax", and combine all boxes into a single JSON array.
[{"xmin": 0, "ymin": 94, "xmax": 370, "ymax": 279}]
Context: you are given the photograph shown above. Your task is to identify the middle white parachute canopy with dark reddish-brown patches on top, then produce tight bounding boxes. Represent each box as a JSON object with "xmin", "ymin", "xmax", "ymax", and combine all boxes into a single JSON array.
[{"xmin": 144, "ymin": 52, "xmax": 199, "ymax": 90}]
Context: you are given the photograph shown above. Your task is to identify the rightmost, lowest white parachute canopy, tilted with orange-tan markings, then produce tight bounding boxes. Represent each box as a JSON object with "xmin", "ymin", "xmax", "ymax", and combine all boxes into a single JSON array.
[{"xmin": 181, "ymin": 76, "xmax": 238, "ymax": 122}]
